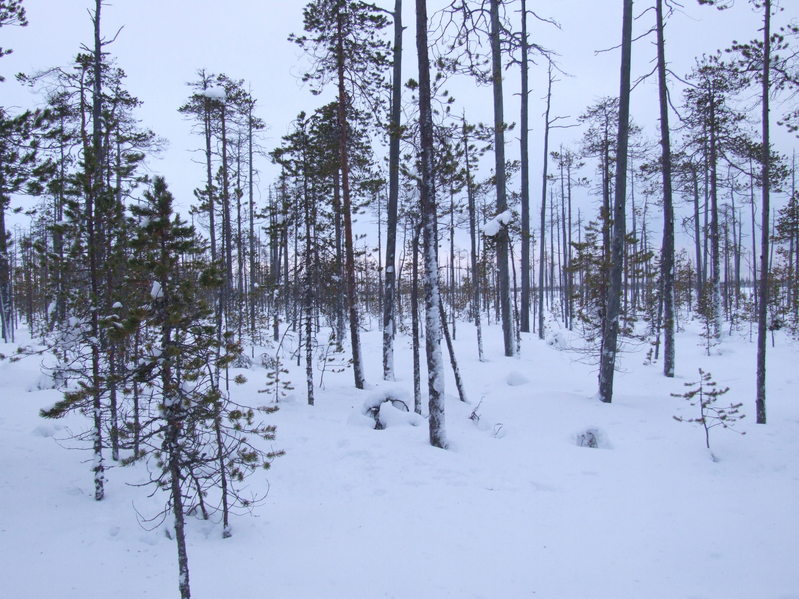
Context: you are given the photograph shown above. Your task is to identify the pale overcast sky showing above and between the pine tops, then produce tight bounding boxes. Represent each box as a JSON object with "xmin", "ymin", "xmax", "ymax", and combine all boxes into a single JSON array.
[{"xmin": 0, "ymin": 0, "xmax": 799, "ymax": 232}]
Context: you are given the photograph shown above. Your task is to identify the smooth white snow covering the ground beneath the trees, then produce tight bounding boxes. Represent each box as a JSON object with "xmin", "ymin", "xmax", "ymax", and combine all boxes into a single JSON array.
[{"xmin": 0, "ymin": 323, "xmax": 799, "ymax": 599}]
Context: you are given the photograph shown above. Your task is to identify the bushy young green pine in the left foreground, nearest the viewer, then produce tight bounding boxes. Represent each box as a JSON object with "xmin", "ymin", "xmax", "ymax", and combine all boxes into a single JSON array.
[{"xmin": 125, "ymin": 178, "xmax": 280, "ymax": 598}]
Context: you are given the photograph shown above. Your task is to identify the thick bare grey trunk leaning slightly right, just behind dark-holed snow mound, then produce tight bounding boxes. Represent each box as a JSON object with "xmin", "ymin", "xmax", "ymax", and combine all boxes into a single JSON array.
[{"xmin": 599, "ymin": 0, "xmax": 633, "ymax": 403}]
